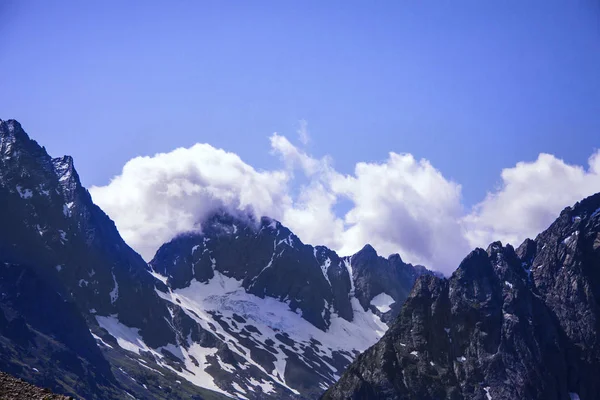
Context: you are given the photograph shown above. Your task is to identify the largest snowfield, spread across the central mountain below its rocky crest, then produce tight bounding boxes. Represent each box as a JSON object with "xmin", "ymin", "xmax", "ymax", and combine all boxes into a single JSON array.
[{"xmin": 156, "ymin": 271, "xmax": 388, "ymax": 394}]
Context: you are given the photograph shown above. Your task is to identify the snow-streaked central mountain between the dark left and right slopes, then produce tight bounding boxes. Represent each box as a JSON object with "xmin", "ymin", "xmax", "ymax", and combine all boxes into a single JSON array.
[{"xmin": 150, "ymin": 211, "xmax": 428, "ymax": 398}]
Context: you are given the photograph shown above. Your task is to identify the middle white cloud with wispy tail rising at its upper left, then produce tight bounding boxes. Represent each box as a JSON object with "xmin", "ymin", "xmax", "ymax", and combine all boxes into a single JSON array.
[{"xmin": 271, "ymin": 134, "xmax": 469, "ymax": 271}]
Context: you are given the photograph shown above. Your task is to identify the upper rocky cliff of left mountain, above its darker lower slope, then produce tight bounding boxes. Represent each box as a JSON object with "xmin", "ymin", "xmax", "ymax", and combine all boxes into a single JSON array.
[{"xmin": 0, "ymin": 121, "xmax": 174, "ymax": 345}]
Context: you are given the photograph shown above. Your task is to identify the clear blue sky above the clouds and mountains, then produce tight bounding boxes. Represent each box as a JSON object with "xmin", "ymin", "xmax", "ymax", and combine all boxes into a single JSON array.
[{"xmin": 0, "ymin": 0, "xmax": 600, "ymax": 270}]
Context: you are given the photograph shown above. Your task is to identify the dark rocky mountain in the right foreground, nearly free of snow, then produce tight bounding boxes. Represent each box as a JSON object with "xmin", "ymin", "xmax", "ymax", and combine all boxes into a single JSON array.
[{"xmin": 322, "ymin": 194, "xmax": 600, "ymax": 400}]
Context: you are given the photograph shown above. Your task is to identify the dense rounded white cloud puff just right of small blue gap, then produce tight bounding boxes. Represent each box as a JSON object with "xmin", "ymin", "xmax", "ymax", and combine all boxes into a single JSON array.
[{"xmin": 332, "ymin": 153, "xmax": 468, "ymax": 270}]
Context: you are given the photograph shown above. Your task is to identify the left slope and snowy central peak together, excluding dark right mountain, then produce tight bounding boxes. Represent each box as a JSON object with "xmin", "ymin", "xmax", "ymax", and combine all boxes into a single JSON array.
[{"xmin": 0, "ymin": 120, "xmax": 429, "ymax": 399}]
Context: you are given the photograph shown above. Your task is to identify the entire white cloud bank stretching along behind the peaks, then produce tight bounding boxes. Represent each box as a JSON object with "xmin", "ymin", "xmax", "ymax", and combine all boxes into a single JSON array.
[{"xmin": 90, "ymin": 134, "xmax": 600, "ymax": 273}]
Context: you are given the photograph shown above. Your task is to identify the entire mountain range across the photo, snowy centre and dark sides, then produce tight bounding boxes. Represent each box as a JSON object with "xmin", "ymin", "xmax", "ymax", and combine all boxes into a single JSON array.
[{"xmin": 0, "ymin": 120, "xmax": 600, "ymax": 400}]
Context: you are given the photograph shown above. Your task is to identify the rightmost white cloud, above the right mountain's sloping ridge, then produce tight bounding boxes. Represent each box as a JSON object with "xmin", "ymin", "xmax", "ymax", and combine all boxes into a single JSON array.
[{"xmin": 464, "ymin": 151, "xmax": 600, "ymax": 246}]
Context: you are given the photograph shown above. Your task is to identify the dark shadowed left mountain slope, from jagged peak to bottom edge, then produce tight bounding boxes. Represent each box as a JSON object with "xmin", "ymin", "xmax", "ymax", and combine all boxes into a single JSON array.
[{"xmin": 0, "ymin": 120, "xmax": 230, "ymax": 399}]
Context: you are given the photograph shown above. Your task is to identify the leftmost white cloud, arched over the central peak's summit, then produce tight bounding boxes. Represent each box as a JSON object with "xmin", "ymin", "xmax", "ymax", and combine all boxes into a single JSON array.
[{"xmin": 90, "ymin": 144, "xmax": 291, "ymax": 260}]
